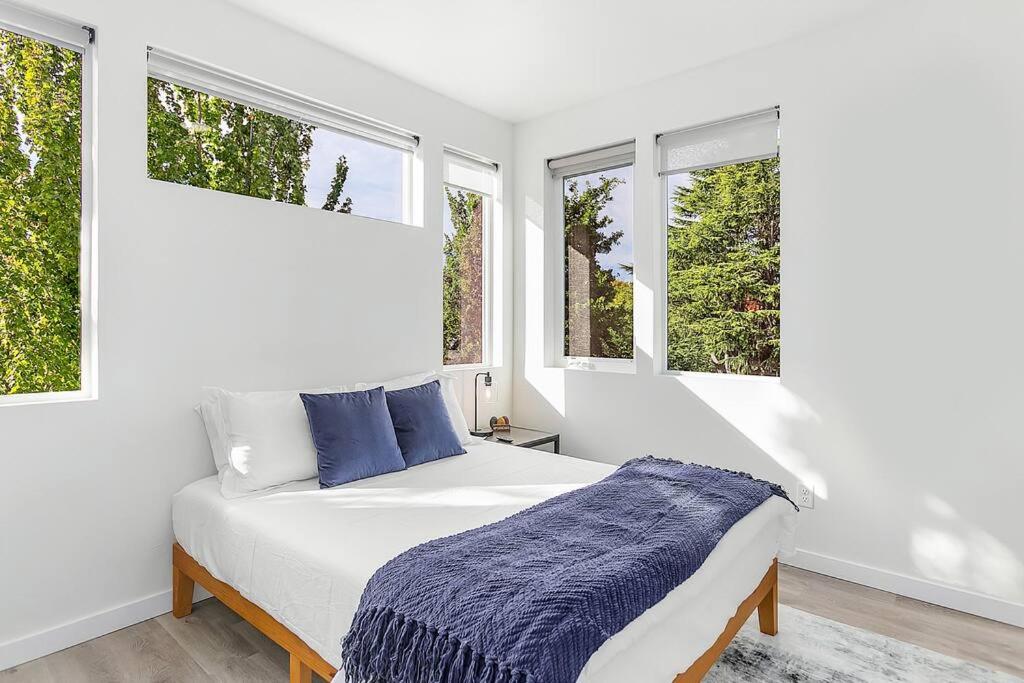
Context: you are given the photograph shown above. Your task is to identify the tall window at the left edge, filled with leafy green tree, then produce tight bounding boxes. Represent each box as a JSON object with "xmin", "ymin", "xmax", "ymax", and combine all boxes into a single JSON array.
[{"xmin": 0, "ymin": 5, "xmax": 93, "ymax": 402}]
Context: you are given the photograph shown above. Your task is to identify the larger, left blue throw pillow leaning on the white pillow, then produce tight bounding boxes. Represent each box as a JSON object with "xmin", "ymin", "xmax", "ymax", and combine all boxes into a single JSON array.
[{"xmin": 299, "ymin": 387, "xmax": 406, "ymax": 488}]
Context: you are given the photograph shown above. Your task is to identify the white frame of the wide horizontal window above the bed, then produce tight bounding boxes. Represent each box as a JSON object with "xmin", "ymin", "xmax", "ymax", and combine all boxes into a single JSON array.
[{"xmin": 146, "ymin": 45, "xmax": 422, "ymax": 227}]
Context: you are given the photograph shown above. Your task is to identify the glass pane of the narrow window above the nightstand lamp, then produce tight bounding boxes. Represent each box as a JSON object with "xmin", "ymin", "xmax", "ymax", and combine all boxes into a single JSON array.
[{"xmin": 442, "ymin": 186, "xmax": 490, "ymax": 366}]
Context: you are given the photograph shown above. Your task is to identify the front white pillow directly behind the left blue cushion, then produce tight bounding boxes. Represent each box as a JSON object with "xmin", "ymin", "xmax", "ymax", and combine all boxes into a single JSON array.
[{"xmin": 198, "ymin": 386, "xmax": 345, "ymax": 498}]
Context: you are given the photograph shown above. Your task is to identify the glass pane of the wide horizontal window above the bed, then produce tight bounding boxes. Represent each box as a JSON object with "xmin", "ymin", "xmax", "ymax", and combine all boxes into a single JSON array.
[{"xmin": 148, "ymin": 78, "xmax": 409, "ymax": 221}]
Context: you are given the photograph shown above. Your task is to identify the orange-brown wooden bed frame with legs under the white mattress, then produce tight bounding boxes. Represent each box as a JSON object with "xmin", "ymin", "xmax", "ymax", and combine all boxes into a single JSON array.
[{"xmin": 171, "ymin": 543, "xmax": 778, "ymax": 683}]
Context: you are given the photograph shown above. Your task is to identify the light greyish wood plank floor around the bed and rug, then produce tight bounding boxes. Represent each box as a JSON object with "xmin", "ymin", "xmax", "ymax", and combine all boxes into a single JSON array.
[{"xmin": 0, "ymin": 566, "xmax": 1024, "ymax": 683}]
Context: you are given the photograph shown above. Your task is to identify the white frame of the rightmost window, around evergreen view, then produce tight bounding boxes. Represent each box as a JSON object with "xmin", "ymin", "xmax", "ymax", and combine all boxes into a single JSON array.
[{"xmin": 653, "ymin": 105, "xmax": 783, "ymax": 384}]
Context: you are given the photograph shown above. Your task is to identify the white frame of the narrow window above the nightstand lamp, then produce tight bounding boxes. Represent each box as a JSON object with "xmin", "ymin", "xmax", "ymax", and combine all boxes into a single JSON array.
[{"xmin": 440, "ymin": 146, "xmax": 501, "ymax": 371}]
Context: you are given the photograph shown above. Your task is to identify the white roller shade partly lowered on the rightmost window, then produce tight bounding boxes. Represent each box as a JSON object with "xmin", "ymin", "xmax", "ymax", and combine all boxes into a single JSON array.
[{"xmin": 657, "ymin": 108, "xmax": 778, "ymax": 175}]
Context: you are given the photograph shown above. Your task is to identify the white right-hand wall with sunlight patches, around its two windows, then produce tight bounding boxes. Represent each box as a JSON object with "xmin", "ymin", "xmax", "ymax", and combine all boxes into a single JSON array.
[{"xmin": 513, "ymin": 0, "xmax": 1024, "ymax": 625}]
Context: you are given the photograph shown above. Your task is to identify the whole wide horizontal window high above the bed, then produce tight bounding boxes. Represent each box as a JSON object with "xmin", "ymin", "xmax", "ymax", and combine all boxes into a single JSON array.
[{"xmin": 147, "ymin": 48, "xmax": 417, "ymax": 223}]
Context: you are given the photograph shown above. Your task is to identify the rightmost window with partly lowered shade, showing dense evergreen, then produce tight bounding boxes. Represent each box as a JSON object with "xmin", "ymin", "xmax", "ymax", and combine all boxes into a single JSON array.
[{"xmin": 658, "ymin": 109, "xmax": 780, "ymax": 377}]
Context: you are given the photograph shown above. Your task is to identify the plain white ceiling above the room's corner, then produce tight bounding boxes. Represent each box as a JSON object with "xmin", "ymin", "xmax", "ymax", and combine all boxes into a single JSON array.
[{"xmin": 229, "ymin": 0, "xmax": 882, "ymax": 122}]
